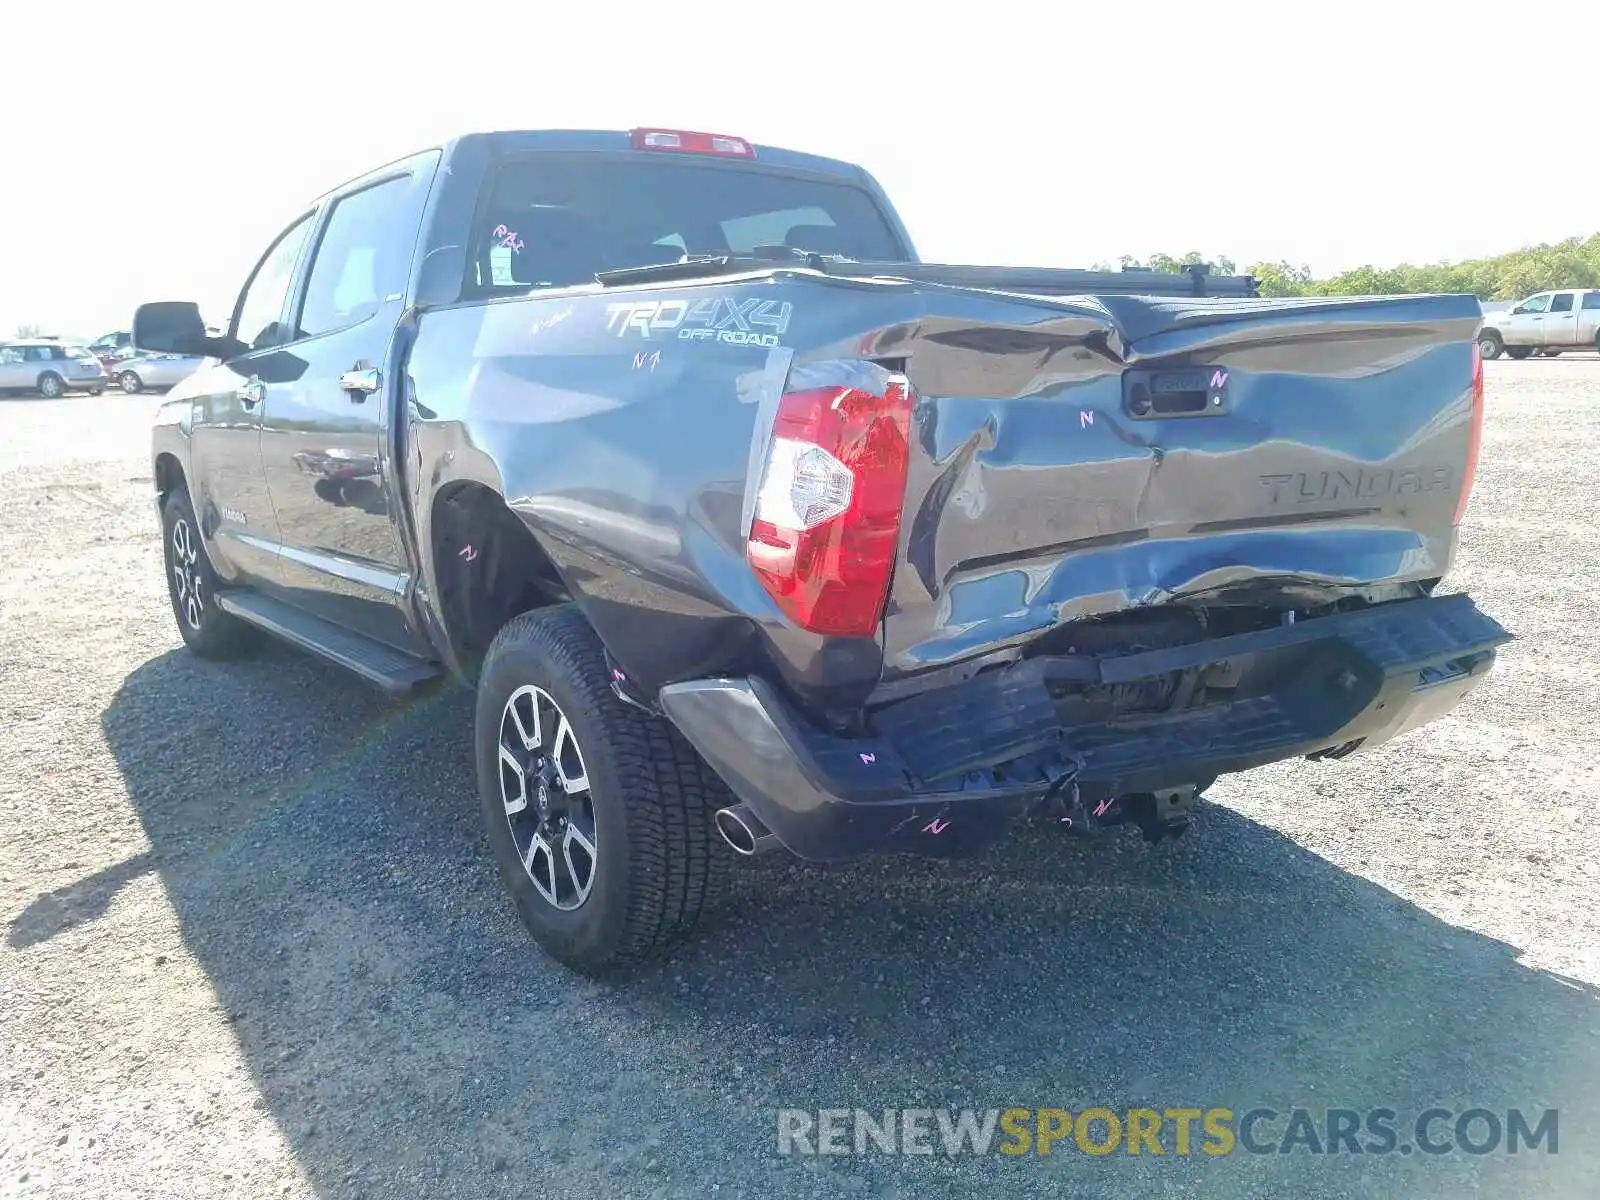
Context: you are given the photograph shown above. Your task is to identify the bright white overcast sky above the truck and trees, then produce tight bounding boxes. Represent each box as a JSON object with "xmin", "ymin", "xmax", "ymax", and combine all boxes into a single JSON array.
[{"xmin": 0, "ymin": 0, "xmax": 1600, "ymax": 338}]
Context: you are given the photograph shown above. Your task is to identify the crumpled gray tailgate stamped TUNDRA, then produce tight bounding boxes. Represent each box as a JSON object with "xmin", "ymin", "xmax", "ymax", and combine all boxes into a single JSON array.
[{"xmin": 859, "ymin": 286, "xmax": 1482, "ymax": 680}]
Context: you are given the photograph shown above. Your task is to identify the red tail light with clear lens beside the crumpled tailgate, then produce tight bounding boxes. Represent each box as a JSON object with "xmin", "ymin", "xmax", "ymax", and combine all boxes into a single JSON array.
[{"xmin": 746, "ymin": 376, "xmax": 910, "ymax": 637}]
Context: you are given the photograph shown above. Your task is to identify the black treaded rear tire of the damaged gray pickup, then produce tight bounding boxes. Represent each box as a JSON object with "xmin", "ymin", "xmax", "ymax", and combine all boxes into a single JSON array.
[{"xmin": 474, "ymin": 605, "xmax": 731, "ymax": 976}]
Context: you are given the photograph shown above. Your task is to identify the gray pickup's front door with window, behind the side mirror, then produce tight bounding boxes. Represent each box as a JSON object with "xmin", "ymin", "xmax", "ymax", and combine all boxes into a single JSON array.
[{"xmin": 184, "ymin": 213, "xmax": 314, "ymax": 582}]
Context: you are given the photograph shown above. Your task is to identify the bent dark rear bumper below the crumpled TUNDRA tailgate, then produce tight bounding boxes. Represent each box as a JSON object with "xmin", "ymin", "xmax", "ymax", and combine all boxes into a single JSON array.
[{"xmin": 661, "ymin": 595, "xmax": 1512, "ymax": 861}]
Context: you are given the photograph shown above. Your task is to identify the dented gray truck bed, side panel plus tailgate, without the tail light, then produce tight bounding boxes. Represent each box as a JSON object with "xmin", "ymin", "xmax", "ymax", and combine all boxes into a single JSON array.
[{"xmin": 405, "ymin": 269, "xmax": 1482, "ymax": 709}]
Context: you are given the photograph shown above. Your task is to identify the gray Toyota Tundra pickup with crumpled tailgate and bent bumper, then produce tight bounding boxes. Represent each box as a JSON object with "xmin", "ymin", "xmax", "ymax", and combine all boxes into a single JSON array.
[{"xmin": 134, "ymin": 130, "xmax": 1510, "ymax": 971}]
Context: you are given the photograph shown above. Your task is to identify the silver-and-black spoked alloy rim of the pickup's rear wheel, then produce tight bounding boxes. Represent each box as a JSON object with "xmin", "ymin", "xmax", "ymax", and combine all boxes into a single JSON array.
[{"xmin": 499, "ymin": 683, "xmax": 598, "ymax": 912}]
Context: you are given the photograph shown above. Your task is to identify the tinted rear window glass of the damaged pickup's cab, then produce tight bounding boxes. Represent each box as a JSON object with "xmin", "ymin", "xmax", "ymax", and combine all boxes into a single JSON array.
[{"xmin": 467, "ymin": 155, "xmax": 906, "ymax": 294}]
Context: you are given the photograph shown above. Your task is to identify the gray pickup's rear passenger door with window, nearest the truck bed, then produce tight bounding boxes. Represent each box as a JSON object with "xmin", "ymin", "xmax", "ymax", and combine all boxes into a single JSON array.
[{"xmin": 261, "ymin": 152, "xmax": 438, "ymax": 650}]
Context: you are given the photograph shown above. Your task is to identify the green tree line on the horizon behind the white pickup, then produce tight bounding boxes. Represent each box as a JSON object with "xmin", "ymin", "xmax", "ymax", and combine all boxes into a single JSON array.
[{"xmin": 1117, "ymin": 234, "xmax": 1600, "ymax": 299}]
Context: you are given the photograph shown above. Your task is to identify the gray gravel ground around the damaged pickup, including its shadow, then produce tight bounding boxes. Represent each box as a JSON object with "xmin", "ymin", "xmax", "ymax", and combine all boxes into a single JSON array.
[{"xmin": 0, "ymin": 357, "xmax": 1600, "ymax": 1198}]
